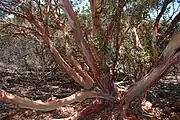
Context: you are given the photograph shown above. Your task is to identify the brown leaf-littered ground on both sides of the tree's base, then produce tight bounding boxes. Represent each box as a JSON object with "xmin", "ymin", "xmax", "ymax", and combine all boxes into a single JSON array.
[{"xmin": 0, "ymin": 63, "xmax": 180, "ymax": 120}]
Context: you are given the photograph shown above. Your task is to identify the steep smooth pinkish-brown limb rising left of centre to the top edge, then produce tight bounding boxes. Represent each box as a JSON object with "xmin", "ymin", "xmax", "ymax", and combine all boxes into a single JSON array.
[{"xmin": 61, "ymin": 0, "xmax": 104, "ymax": 90}]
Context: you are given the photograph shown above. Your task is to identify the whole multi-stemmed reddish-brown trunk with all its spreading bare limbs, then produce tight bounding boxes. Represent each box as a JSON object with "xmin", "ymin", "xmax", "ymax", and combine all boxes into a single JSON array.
[{"xmin": 0, "ymin": 0, "xmax": 180, "ymax": 117}]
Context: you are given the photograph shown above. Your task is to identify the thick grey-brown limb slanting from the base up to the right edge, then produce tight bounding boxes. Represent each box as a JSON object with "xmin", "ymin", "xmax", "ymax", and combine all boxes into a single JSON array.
[{"xmin": 115, "ymin": 33, "xmax": 180, "ymax": 114}]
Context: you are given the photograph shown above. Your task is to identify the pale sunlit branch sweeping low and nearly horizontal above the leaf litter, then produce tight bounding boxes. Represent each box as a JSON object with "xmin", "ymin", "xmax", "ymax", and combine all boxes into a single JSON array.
[{"xmin": 0, "ymin": 90, "xmax": 100, "ymax": 111}]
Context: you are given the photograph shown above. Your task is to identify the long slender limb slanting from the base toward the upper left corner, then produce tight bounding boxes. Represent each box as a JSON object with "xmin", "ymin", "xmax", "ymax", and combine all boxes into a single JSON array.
[{"xmin": 11, "ymin": 0, "xmax": 90, "ymax": 89}]
